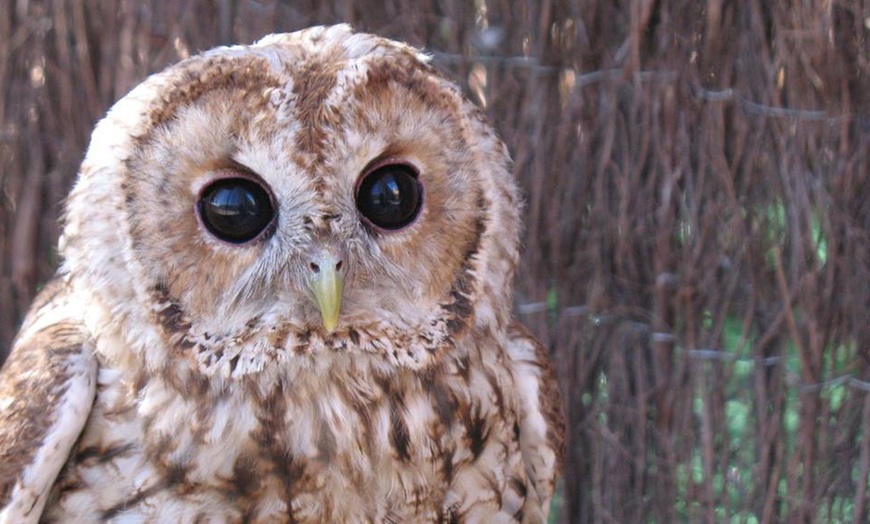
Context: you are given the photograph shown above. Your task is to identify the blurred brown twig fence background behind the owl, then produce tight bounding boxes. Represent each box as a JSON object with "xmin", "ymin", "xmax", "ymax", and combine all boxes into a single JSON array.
[{"xmin": 0, "ymin": 0, "xmax": 870, "ymax": 522}]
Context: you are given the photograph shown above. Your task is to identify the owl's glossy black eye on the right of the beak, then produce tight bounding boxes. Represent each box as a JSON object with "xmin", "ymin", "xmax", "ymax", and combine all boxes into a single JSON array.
[{"xmin": 356, "ymin": 164, "xmax": 423, "ymax": 231}]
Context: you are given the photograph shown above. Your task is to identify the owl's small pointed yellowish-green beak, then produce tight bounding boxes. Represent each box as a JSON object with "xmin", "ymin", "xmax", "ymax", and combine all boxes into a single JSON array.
[{"xmin": 308, "ymin": 247, "xmax": 347, "ymax": 333}]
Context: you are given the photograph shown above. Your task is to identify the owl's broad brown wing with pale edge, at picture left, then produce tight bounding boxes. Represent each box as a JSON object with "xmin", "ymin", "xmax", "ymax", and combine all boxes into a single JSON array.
[{"xmin": 0, "ymin": 277, "xmax": 97, "ymax": 523}]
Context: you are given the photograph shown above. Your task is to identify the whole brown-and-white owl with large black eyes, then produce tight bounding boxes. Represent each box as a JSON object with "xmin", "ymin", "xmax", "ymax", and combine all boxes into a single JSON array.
[{"xmin": 0, "ymin": 25, "xmax": 564, "ymax": 523}]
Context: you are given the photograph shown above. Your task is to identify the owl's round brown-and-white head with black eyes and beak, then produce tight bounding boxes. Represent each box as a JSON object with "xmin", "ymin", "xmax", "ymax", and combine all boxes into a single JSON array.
[{"xmin": 62, "ymin": 25, "xmax": 519, "ymax": 374}]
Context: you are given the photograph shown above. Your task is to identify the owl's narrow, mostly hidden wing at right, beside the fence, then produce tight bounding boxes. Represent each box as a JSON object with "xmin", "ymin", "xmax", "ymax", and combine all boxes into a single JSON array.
[{"xmin": 507, "ymin": 322, "xmax": 565, "ymax": 522}]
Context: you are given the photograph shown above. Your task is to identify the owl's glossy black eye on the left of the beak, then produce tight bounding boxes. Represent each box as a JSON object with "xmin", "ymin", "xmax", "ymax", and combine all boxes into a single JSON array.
[{"xmin": 197, "ymin": 178, "xmax": 275, "ymax": 244}]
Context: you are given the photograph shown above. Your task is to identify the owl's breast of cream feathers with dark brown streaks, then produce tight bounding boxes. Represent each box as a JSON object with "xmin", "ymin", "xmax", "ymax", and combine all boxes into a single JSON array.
[{"xmin": 46, "ymin": 338, "xmax": 527, "ymax": 522}]
